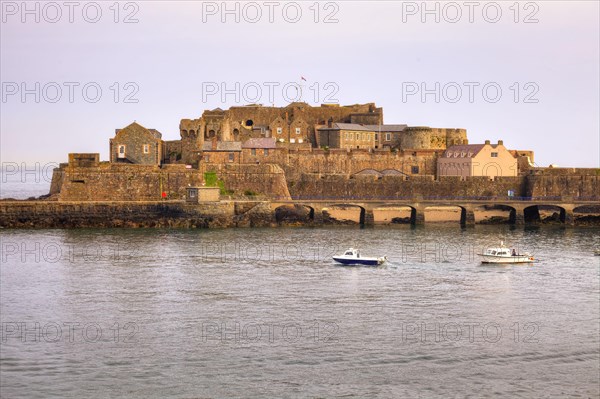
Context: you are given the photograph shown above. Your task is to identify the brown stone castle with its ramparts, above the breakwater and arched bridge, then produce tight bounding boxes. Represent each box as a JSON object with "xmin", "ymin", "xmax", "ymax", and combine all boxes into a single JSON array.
[{"xmin": 50, "ymin": 103, "xmax": 568, "ymax": 201}]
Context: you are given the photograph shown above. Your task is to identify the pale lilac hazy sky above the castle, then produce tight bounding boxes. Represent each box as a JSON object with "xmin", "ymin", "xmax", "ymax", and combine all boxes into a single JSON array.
[{"xmin": 0, "ymin": 1, "xmax": 600, "ymax": 167}]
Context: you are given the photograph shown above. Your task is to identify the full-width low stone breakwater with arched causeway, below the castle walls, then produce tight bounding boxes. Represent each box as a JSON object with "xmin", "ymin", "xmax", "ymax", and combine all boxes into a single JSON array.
[{"xmin": 0, "ymin": 198, "xmax": 600, "ymax": 228}]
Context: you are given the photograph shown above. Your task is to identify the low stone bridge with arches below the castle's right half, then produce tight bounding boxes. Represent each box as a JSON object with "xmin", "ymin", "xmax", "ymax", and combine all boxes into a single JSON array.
[{"xmin": 271, "ymin": 197, "xmax": 600, "ymax": 226}]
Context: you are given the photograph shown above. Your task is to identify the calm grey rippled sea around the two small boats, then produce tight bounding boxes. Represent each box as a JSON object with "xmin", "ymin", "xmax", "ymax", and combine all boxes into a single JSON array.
[{"xmin": 0, "ymin": 224, "xmax": 600, "ymax": 398}]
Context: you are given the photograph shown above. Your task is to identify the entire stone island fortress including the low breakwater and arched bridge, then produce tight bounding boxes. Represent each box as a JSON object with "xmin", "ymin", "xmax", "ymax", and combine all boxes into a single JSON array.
[{"xmin": 0, "ymin": 103, "xmax": 600, "ymax": 227}]
